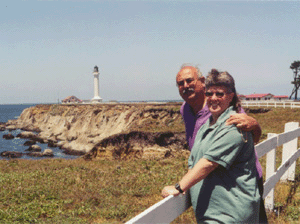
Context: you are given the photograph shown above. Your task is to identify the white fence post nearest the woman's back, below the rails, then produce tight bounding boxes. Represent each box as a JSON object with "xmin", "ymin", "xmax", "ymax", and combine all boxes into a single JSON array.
[{"xmin": 265, "ymin": 133, "xmax": 277, "ymax": 211}]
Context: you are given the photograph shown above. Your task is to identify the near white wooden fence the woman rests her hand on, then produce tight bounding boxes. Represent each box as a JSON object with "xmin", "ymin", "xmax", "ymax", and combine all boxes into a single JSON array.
[{"xmin": 126, "ymin": 122, "xmax": 300, "ymax": 224}]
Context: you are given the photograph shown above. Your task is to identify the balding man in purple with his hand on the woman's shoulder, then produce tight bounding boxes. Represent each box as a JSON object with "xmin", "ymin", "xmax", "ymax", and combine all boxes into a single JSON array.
[{"xmin": 176, "ymin": 65, "xmax": 268, "ymax": 223}]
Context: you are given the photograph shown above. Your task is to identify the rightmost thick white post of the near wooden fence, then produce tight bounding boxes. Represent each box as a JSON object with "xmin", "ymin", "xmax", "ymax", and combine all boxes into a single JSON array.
[{"xmin": 280, "ymin": 122, "xmax": 299, "ymax": 181}]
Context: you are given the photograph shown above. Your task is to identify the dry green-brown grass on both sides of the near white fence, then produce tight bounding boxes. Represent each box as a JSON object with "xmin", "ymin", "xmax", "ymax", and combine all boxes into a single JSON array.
[{"xmin": 0, "ymin": 108, "xmax": 300, "ymax": 223}]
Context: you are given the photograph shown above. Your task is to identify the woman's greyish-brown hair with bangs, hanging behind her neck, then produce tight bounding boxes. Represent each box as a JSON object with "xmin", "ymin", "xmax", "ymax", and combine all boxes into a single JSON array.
[{"xmin": 205, "ymin": 69, "xmax": 241, "ymax": 112}]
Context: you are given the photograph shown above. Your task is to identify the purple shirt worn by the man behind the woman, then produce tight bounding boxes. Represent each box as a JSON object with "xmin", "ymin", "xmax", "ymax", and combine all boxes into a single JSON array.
[{"xmin": 180, "ymin": 102, "xmax": 262, "ymax": 178}]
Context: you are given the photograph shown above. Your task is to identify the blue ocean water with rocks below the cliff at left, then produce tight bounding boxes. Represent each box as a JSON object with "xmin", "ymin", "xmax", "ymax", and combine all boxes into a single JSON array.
[{"xmin": 0, "ymin": 104, "xmax": 78, "ymax": 160}]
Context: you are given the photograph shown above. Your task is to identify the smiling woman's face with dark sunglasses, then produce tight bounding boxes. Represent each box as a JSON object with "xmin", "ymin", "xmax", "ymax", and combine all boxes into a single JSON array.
[{"xmin": 205, "ymin": 86, "xmax": 234, "ymax": 119}]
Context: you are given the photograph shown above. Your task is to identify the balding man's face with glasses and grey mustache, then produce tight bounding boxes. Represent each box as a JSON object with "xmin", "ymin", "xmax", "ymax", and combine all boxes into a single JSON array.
[{"xmin": 176, "ymin": 67, "xmax": 205, "ymax": 104}]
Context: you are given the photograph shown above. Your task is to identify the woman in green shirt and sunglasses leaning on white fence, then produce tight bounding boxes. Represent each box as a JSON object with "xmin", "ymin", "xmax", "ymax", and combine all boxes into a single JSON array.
[{"xmin": 162, "ymin": 69, "xmax": 260, "ymax": 223}]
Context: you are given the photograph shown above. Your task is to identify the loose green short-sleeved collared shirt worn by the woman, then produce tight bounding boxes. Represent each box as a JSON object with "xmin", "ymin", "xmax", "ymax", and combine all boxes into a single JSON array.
[{"xmin": 188, "ymin": 107, "xmax": 260, "ymax": 223}]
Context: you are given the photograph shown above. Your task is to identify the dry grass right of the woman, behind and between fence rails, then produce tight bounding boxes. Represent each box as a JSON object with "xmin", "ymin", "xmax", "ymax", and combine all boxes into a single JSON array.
[{"xmin": 249, "ymin": 108, "xmax": 300, "ymax": 223}]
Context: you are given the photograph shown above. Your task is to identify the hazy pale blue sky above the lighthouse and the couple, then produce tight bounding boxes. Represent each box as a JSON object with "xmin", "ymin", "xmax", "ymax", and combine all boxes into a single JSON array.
[{"xmin": 0, "ymin": 0, "xmax": 300, "ymax": 104}]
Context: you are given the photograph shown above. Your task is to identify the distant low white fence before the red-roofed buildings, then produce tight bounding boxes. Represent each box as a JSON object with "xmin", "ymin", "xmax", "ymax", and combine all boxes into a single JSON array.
[{"xmin": 241, "ymin": 100, "xmax": 300, "ymax": 109}]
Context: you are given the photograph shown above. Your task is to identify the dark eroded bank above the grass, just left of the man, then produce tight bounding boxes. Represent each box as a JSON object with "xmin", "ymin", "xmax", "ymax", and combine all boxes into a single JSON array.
[{"xmin": 84, "ymin": 131, "xmax": 189, "ymax": 160}]
